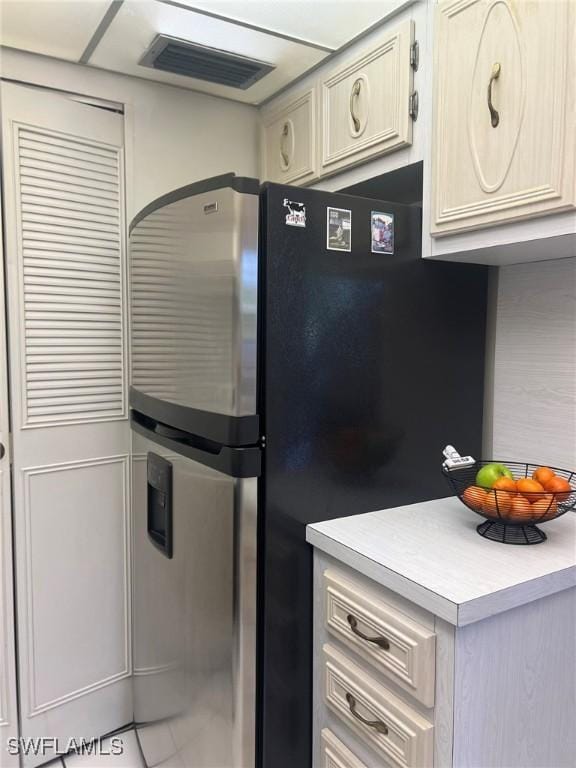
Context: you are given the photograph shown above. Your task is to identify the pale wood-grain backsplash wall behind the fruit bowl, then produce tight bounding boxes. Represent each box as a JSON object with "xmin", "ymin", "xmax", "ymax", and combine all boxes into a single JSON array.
[{"xmin": 492, "ymin": 258, "xmax": 576, "ymax": 469}]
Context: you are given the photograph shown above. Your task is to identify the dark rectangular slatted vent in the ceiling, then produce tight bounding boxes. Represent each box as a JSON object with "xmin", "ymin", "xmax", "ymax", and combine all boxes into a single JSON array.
[{"xmin": 140, "ymin": 35, "xmax": 274, "ymax": 90}]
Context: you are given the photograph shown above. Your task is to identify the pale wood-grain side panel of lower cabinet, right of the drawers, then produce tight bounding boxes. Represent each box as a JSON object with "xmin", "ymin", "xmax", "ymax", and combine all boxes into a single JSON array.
[{"xmin": 453, "ymin": 588, "xmax": 576, "ymax": 768}]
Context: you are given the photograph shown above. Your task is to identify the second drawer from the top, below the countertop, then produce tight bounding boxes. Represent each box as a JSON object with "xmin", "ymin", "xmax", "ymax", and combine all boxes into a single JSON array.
[{"xmin": 323, "ymin": 645, "xmax": 434, "ymax": 768}]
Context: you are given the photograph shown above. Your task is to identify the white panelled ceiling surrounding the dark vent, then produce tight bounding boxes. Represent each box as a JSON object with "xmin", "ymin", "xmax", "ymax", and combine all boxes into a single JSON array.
[{"xmin": 0, "ymin": 0, "xmax": 399, "ymax": 104}]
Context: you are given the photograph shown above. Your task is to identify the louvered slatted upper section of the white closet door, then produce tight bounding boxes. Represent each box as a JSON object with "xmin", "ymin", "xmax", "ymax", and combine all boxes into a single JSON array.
[{"xmin": 18, "ymin": 127, "xmax": 126, "ymax": 426}]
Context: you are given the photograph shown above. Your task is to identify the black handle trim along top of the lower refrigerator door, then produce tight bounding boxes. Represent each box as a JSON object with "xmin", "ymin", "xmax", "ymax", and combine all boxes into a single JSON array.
[{"xmin": 130, "ymin": 411, "xmax": 262, "ymax": 478}]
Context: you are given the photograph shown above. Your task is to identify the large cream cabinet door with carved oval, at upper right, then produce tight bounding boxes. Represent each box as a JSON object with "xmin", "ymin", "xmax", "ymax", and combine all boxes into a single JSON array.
[{"xmin": 432, "ymin": 0, "xmax": 576, "ymax": 235}]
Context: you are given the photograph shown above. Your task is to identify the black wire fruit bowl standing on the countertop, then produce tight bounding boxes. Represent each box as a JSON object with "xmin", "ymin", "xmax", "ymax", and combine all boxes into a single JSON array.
[{"xmin": 442, "ymin": 460, "xmax": 576, "ymax": 544}]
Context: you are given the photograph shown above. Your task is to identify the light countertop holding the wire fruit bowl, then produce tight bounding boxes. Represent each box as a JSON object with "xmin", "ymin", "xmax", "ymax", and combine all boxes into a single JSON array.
[{"xmin": 306, "ymin": 497, "xmax": 576, "ymax": 626}]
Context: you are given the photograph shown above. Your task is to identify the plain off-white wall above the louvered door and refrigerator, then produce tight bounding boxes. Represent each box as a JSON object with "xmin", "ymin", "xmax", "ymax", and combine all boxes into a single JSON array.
[{"xmin": 0, "ymin": 49, "xmax": 258, "ymax": 221}]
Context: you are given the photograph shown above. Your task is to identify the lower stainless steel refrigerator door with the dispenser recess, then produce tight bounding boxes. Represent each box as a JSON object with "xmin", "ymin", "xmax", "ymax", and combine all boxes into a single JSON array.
[{"xmin": 133, "ymin": 434, "xmax": 257, "ymax": 768}]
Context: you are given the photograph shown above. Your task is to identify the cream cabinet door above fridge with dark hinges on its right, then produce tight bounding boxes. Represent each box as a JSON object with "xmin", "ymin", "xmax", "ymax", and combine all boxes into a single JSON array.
[{"xmin": 321, "ymin": 21, "xmax": 414, "ymax": 175}]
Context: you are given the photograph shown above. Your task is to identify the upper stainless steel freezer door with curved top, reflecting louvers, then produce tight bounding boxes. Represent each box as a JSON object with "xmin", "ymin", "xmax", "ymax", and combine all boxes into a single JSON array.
[{"xmin": 130, "ymin": 176, "xmax": 258, "ymax": 432}]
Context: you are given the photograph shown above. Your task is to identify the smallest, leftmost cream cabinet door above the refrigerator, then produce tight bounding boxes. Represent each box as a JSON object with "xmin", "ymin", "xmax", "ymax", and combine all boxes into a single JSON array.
[{"xmin": 261, "ymin": 88, "xmax": 317, "ymax": 184}]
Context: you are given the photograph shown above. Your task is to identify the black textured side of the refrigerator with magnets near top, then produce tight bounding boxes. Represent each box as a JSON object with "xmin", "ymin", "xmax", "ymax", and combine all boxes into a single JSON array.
[{"xmin": 260, "ymin": 184, "xmax": 487, "ymax": 768}]
